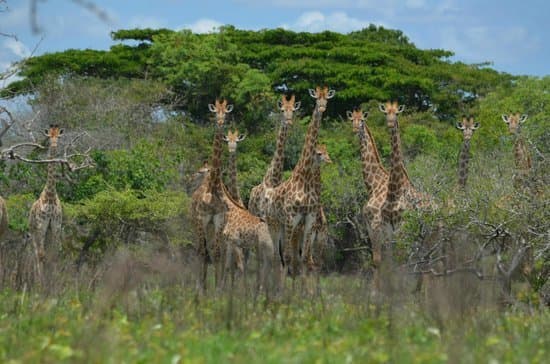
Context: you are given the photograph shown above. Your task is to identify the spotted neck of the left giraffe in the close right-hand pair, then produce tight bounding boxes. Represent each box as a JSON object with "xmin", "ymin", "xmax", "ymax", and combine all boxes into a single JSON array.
[{"xmin": 359, "ymin": 123, "xmax": 388, "ymax": 195}]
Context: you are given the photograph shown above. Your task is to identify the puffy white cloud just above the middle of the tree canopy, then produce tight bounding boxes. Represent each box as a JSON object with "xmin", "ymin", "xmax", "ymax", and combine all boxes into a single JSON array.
[{"xmin": 282, "ymin": 11, "xmax": 380, "ymax": 33}]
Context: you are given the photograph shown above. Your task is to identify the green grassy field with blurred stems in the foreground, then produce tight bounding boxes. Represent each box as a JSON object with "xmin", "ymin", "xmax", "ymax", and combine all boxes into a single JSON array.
[{"xmin": 0, "ymin": 258, "xmax": 550, "ymax": 363}]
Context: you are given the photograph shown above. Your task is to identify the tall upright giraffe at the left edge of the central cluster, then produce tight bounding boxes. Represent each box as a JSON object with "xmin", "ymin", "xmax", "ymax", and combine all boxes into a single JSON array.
[{"xmin": 191, "ymin": 100, "xmax": 233, "ymax": 290}]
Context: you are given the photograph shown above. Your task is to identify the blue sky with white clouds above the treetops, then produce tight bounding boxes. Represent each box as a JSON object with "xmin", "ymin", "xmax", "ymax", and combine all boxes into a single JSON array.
[{"xmin": 0, "ymin": 0, "xmax": 550, "ymax": 81}]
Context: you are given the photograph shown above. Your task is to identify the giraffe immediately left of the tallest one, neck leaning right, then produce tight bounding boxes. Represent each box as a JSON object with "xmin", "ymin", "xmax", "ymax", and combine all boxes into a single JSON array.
[{"xmin": 248, "ymin": 95, "xmax": 300, "ymax": 216}]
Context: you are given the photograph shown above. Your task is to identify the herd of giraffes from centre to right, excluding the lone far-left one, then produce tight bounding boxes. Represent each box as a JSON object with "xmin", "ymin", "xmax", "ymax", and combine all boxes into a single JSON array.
[{"xmin": 187, "ymin": 87, "xmax": 530, "ymax": 292}]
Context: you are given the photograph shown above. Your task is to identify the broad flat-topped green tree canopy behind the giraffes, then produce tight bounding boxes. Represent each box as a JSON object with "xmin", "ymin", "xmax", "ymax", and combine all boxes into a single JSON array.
[{"xmin": 3, "ymin": 25, "xmax": 513, "ymax": 126}]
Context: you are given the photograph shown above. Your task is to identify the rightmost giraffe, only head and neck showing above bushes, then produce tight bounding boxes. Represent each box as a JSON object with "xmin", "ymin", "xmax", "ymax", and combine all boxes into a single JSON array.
[{"xmin": 502, "ymin": 113, "xmax": 531, "ymax": 188}]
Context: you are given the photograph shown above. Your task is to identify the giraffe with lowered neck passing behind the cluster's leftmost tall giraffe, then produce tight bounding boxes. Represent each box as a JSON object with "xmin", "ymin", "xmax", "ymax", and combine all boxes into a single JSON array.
[{"xmin": 192, "ymin": 163, "xmax": 278, "ymax": 295}]
